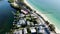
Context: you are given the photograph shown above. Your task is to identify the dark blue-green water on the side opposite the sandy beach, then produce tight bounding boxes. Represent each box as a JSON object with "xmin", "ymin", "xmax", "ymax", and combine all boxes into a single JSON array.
[{"xmin": 0, "ymin": 0, "xmax": 16, "ymax": 34}]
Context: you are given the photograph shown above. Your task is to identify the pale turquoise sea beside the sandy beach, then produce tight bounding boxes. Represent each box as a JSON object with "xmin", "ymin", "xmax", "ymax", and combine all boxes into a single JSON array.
[{"xmin": 27, "ymin": 0, "xmax": 60, "ymax": 30}]
